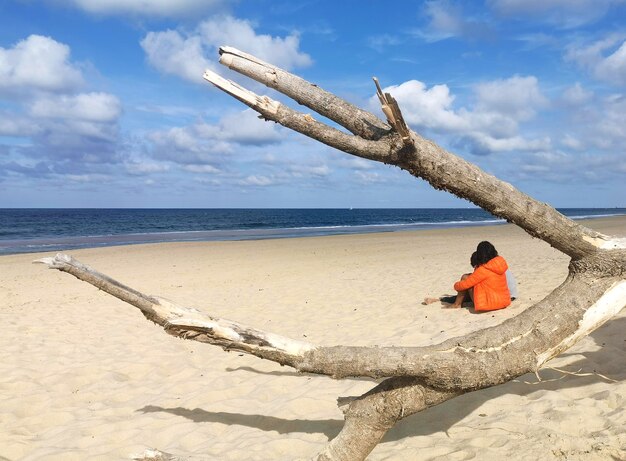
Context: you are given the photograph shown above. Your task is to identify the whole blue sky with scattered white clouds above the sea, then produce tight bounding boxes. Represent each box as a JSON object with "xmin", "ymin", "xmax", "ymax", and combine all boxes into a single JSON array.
[{"xmin": 0, "ymin": 0, "xmax": 626, "ymax": 208}]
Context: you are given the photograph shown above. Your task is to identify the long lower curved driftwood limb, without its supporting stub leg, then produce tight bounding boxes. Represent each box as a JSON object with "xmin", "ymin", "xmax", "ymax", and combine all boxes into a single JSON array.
[{"xmin": 34, "ymin": 254, "xmax": 626, "ymax": 390}]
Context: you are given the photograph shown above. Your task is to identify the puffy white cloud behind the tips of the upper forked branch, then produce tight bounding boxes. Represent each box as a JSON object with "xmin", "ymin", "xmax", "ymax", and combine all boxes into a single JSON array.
[{"xmin": 141, "ymin": 16, "xmax": 311, "ymax": 82}]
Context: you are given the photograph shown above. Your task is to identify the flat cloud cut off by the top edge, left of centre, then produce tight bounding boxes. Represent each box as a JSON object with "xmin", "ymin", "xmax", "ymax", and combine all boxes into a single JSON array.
[{"xmin": 52, "ymin": 0, "xmax": 229, "ymax": 17}]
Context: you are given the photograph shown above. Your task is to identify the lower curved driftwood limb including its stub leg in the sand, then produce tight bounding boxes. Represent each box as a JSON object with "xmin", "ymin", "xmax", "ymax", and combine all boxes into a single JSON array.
[{"xmin": 38, "ymin": 250, "xmax": 626, "ymax": 461}]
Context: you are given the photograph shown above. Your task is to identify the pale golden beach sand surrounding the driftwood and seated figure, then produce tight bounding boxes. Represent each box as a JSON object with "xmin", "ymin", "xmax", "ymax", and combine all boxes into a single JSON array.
[{"xmin": 0, "ymin": 217, "xmax": 626, "ymax": 461}]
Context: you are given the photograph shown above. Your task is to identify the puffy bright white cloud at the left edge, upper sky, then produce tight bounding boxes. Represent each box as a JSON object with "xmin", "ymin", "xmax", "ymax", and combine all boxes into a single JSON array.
[{"xmin": 0, "ymin": 35, "xmax": 83, "ymax": 94}]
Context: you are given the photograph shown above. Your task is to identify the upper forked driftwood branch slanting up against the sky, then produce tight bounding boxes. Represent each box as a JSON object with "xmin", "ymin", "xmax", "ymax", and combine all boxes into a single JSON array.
[{"xmin": 204, "ymin": 47, "xmax": 619, "ymax": 259}]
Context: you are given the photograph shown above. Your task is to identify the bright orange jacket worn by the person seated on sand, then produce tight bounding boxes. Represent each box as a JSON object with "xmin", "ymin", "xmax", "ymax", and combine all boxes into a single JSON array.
[{"xmin": 454, "ymin": 256, "xmax": 511, "ymax": 311}]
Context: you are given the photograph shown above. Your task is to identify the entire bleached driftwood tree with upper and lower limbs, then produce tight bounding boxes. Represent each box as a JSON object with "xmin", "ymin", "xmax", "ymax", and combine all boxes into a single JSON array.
[{"xmin": 42, "ymin": 47, "xmax": 626, "ymax": 461}]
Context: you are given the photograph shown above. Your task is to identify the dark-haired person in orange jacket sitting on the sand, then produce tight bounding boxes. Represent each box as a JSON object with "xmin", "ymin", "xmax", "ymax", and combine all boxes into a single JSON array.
[{"xmin": 423, "ymin": 241, "xmax": 510, "ymax": 312}]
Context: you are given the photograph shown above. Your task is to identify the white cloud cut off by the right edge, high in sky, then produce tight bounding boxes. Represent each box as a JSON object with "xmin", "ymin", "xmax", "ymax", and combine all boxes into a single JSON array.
[{"xmin": 565, "ymin": 35, "xmax": 626, "ymax": 86}]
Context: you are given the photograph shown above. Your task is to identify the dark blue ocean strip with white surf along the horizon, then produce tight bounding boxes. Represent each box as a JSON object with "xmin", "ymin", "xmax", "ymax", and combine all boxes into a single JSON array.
[{"xmin": 0, "ymin": 208, "xmax": 626, "ymax": 255}]
